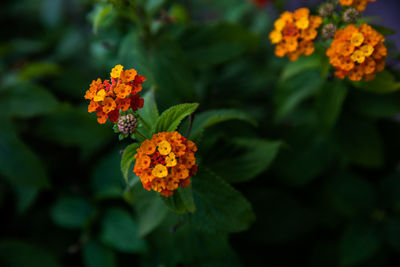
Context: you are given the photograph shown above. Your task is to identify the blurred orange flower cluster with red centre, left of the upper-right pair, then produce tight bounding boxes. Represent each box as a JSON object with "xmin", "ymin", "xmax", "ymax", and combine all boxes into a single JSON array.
[{"xmin": 269, "ymin": 8, "xmax": 322, "ymax": 61}]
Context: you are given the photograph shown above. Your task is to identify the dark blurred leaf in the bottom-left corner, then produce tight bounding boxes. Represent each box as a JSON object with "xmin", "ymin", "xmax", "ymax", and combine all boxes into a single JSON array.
[{"xmin": 0, "ymin": 240, "xmax": 61, "ymax": 267}]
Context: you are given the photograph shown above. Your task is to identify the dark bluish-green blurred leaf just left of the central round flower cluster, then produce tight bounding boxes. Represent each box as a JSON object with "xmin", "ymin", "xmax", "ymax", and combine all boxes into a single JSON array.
[{"xmin": 91, "ymin": 148, "xmax": 124, "ymax": 199}]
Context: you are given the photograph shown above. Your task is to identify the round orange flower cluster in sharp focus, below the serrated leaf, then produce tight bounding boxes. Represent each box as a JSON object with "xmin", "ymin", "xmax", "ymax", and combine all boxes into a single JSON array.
[{"xmin": 133, "ymin": 132, "xmax": 197, "ymax": 197}]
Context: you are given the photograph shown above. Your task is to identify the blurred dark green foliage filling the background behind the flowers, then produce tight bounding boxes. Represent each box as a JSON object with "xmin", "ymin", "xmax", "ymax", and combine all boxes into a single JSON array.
[{"xmin": 0, "ymin": 0, "xmax": 400, "ymax": 267}]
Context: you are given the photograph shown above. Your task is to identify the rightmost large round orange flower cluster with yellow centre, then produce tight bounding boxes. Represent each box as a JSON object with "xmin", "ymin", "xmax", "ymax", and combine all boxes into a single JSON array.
[{"xmin": 326, "ymin": 24, "xmax": 387, "ymax": 81}]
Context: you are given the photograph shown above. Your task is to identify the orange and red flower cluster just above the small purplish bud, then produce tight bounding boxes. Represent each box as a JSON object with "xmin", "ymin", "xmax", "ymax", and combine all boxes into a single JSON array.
[{"xmin": 85, "ymin": 65, "xmax": 146, "ymax": 124}]
